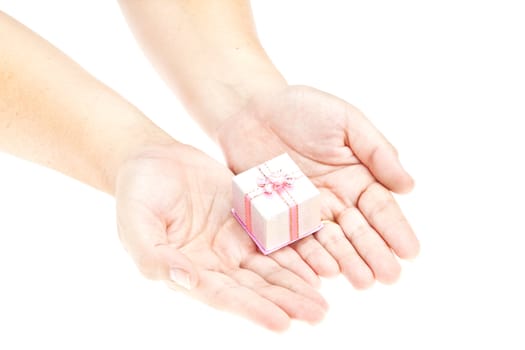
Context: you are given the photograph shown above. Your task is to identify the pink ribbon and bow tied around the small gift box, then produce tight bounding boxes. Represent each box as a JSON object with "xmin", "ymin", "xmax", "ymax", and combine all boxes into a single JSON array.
[{"xmin": 244, "ymin": 164, "xmax": 299, "ymax": 241}]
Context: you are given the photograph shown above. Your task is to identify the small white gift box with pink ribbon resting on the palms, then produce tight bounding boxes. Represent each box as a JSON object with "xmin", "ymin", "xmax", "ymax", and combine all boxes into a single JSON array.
[{"xmin": 232, "ymin": 154, "xmax": 322, "ymax": 254}]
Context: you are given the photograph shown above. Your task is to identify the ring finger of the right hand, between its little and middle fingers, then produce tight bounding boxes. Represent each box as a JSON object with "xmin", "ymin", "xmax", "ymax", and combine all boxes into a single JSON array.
[{"xmin": 315, "ymin": 221, "xmax": 374, "ymax": 289}]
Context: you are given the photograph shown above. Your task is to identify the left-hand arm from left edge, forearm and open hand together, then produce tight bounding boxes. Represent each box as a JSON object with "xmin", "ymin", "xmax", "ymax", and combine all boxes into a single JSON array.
[{"xmin": 0, "ymin": 12, "xmax": 327, "ymax": 331}]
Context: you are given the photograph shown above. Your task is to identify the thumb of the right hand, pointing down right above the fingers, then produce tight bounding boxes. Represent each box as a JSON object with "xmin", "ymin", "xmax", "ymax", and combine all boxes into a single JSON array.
[{"xmin": 346, "ymin": 106, "xmax": 414, "ymax": 193}]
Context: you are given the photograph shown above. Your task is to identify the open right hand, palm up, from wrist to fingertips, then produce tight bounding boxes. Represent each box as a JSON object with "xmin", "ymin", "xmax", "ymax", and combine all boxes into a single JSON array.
[{"xmin": 217, "ymin": 86, "xmax": 419, "ymax": 288}]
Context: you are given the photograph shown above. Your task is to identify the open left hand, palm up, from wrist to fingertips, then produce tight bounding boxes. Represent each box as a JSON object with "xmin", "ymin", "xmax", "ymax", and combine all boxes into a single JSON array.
[{"xmin": 116, "ymin": 144, "xmax": 327, "ymax": 330}]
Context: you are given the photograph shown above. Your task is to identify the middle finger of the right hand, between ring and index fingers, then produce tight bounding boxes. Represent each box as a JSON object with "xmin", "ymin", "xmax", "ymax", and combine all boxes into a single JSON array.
[{"xmin": 337, "ymin": 207, "xmax": 401, "ymax": 284}]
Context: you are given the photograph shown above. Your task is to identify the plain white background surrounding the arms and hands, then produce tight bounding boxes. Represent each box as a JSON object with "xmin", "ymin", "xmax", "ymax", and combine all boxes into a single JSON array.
[{"xmin": 0, "ymin": 0, "xmax": 525, "ymax": 349}]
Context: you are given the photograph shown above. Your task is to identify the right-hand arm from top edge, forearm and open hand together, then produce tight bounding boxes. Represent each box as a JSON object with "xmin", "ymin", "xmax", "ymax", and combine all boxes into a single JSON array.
[{"xmin": 120, "ymin": 0, "xmax": 419, "ymax": 288}]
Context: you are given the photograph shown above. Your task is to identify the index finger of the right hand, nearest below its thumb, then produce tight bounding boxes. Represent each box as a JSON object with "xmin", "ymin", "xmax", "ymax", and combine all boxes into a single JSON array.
[{"xmin": 357, "ymin": 183, "xmax": 419, "ymax": 259}]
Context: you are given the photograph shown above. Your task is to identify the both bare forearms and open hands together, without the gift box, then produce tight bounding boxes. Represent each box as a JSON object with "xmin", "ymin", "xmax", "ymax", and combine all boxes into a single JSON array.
[{"xmin": 0, "ymin": 0, "xmax": 418, "ymax": 331}]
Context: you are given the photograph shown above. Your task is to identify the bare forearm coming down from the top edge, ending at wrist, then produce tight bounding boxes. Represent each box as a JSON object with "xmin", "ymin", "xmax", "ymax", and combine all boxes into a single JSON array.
[{"xmin": 120, "ymin": 0, "xmax": 286, "ymax": 138}]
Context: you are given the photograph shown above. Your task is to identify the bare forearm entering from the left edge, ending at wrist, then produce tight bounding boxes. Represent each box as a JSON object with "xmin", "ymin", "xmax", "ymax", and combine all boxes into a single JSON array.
[{"xmin": 0, "ymin": 12, "xmax": 175, "ymax": 193}]
